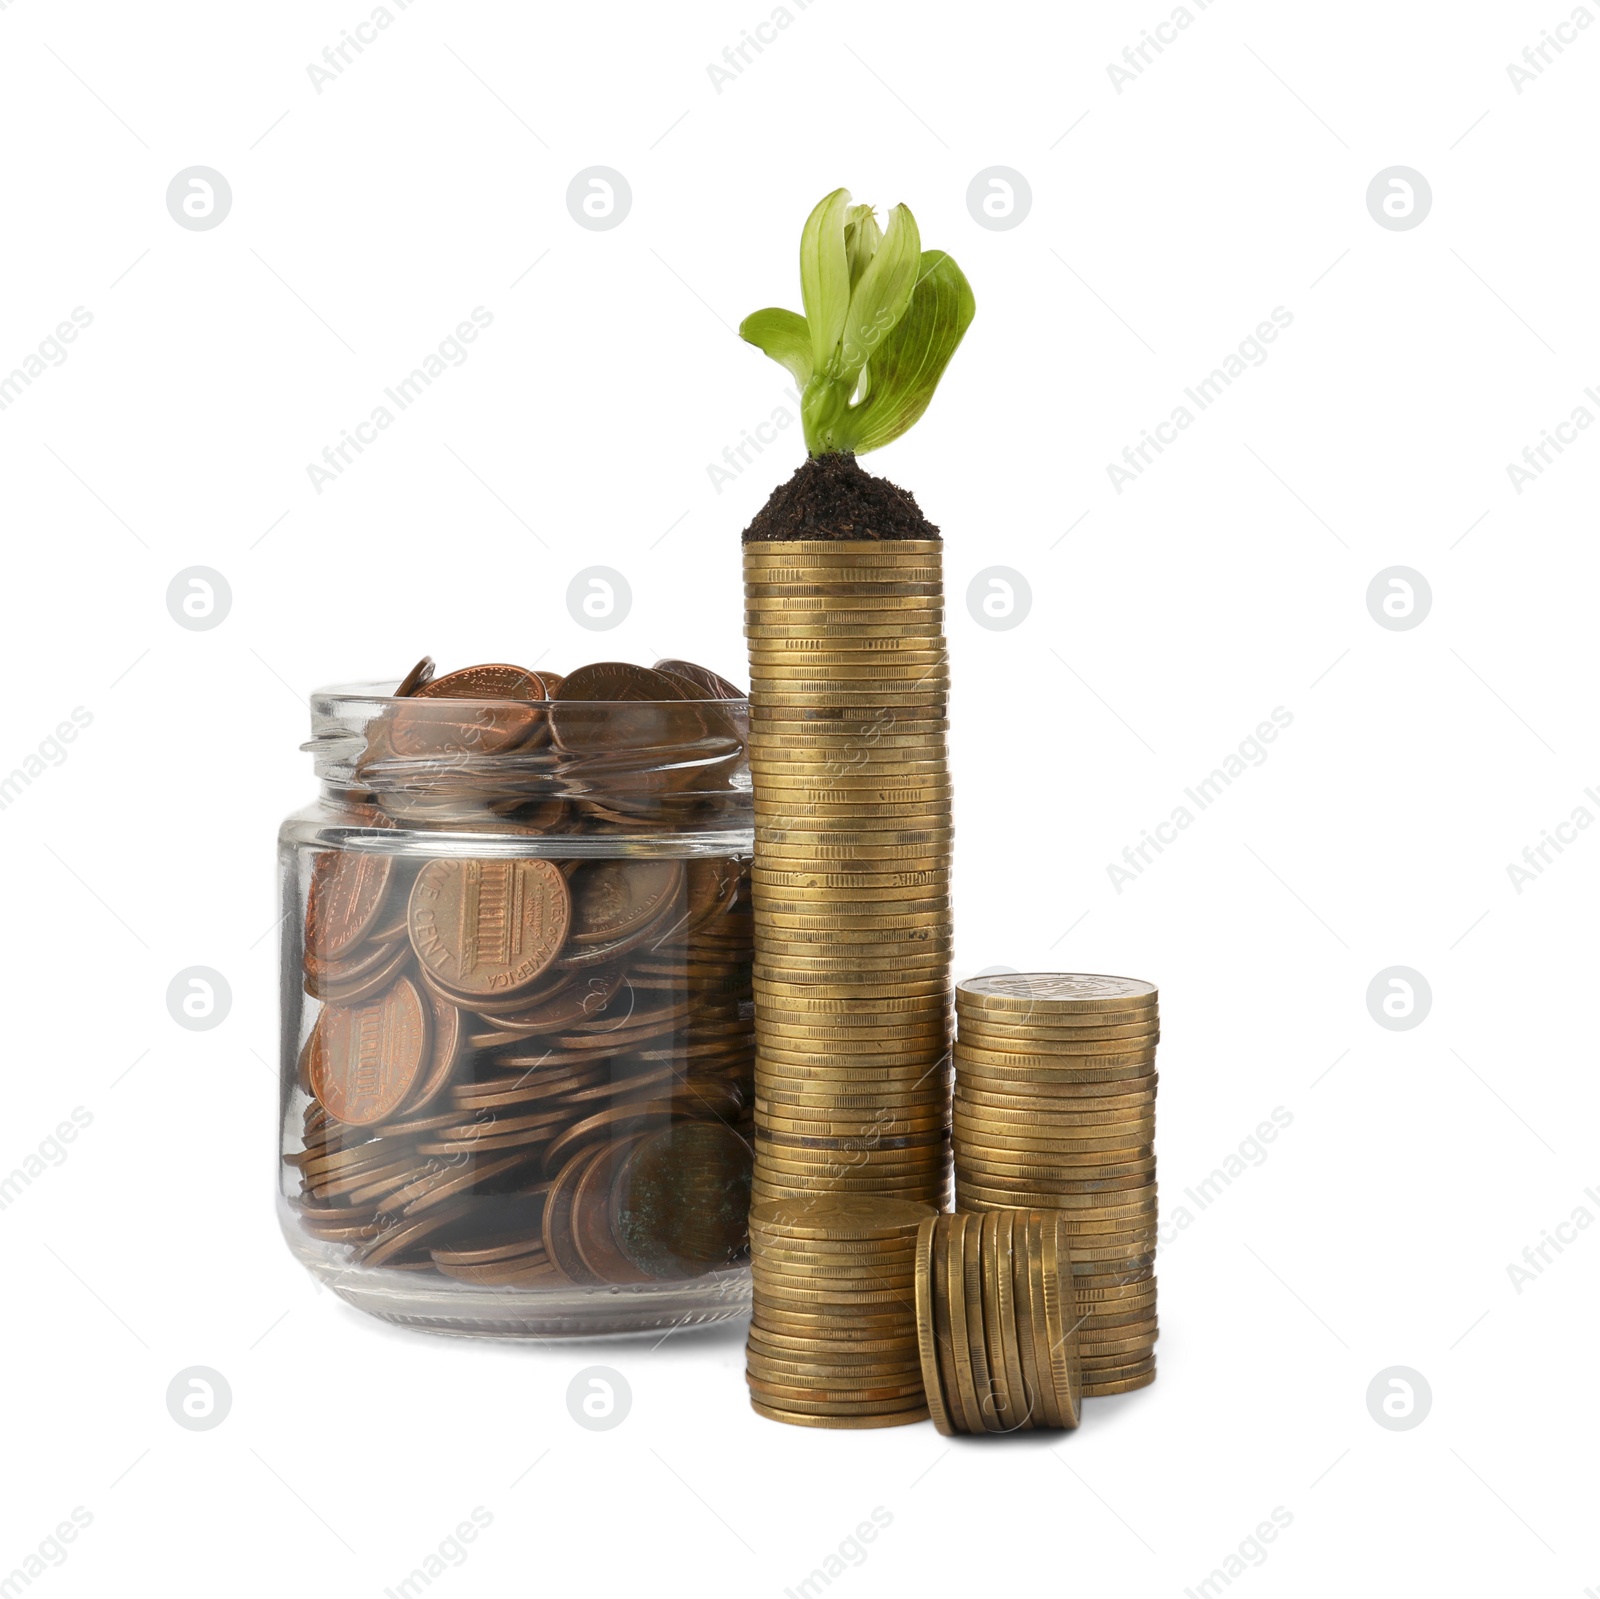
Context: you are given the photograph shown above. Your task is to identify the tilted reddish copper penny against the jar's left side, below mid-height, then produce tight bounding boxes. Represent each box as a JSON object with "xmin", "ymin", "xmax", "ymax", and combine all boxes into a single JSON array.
[{"xmin": 307, "ymin": 978, "xmax": 430, "ymax": 1127}]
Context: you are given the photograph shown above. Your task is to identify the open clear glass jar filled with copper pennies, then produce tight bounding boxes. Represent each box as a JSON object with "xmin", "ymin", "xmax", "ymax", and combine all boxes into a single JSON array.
[{"xmin": 278, "ymin": 675, "xmax": 754, "ymax": 1338}]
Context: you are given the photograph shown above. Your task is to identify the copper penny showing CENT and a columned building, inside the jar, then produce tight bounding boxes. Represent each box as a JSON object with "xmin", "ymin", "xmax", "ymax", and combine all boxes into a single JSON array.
[{"xmin": 408, "ymin": 860, "xmax": 571, "ymax": 996}]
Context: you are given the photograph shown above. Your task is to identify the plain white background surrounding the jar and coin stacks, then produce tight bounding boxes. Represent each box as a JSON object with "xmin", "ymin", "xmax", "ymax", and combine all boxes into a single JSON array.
[{"xmin": 0, "ymin": 0, "xmax": 1600, "ymax": 1599}]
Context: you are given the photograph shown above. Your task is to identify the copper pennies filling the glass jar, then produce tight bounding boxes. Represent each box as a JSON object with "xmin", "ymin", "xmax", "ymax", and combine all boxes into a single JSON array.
[{"xmin": 283, "ymin": 661, "xmax": 754, "ymax": 1287}]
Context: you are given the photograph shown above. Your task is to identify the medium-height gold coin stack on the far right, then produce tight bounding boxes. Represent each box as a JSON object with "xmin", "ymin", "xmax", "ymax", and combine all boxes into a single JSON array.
[{"xmin": 954, "ymin": 972, "xmax": 1160, "ymax": 1396}]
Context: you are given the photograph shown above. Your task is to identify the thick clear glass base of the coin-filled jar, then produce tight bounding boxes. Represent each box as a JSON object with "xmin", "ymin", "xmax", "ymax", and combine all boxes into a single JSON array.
[{"xmin": 283, "ymin": 1223, "xmax": 750, "ymax": 1340}]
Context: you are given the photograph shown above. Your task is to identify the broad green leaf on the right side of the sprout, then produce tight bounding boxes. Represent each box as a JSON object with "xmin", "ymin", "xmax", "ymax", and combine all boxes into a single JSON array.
[{"xmin": 832, "ymin": 250, "xmax": 978, "ymax": 455}]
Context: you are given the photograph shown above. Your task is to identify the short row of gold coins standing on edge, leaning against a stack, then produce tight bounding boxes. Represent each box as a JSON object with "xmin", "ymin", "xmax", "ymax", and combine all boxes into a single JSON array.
[{"xmin": 917, "ymin": 1210, "xmax": 1082, "ymax": 1434}]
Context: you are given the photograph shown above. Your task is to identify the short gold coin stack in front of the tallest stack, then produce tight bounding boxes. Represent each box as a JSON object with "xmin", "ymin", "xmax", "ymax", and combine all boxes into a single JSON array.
[{"xmin": 746, "ymin": 1196, "xmax": 934, "ymax": 1428}]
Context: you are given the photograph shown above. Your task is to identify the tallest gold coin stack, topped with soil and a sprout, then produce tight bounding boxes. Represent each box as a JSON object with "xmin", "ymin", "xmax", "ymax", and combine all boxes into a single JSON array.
[{"xmin": 744, "ymin": 539, "xmax": 950, "ymax": 1204}]
